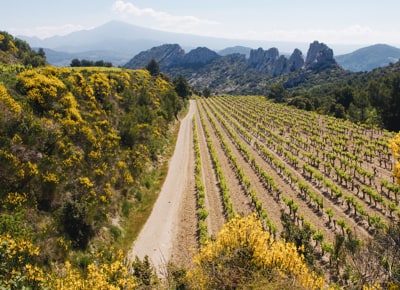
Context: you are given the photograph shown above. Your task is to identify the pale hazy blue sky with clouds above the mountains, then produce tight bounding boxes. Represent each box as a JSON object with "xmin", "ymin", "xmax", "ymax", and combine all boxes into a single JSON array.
[{"xmin": 0, "ymin": 0, "xmax": 400, "ymax": 46}]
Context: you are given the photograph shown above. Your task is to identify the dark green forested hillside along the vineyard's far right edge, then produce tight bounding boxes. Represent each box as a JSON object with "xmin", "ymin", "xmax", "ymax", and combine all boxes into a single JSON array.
[{"xmin": 284, "ymin": 62, "xmax": 400, "ymax": 131}]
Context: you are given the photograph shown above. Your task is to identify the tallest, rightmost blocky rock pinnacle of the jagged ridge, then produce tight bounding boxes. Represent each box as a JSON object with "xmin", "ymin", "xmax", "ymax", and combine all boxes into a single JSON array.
[{"xmin": 304, "ymin": 41, "xmax": 337, "ymax": 72}]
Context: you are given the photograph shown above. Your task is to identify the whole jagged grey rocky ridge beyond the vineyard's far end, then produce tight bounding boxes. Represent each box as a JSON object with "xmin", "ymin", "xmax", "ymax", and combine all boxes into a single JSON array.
[{"xmin": 124, "ymin": 41, "xmax": 340, "ymax": 94}]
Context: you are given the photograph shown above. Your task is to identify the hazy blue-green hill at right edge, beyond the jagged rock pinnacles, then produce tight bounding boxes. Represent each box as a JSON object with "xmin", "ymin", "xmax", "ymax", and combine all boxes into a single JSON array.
[{"xmin": 335, "ymin": 44, "xmax": 400, "ymax": 72}]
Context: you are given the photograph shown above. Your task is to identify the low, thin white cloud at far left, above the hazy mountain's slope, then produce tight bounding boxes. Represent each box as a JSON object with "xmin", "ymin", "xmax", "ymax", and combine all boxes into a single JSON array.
[{"xmin": 10, "ymin": 24, "xmax": 85, "ymax": 39}]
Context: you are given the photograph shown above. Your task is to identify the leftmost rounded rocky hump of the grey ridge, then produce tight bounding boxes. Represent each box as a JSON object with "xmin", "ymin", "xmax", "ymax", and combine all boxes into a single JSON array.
[{"xmin": 124, "ymin": 44, "xmax": 185, "ymax": 70}]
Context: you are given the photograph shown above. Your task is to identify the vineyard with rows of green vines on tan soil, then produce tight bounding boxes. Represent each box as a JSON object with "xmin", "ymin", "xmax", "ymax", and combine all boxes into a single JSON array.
[{"xmin": 175, "ymin": 96, "xmax": 400, "ymax": 284}]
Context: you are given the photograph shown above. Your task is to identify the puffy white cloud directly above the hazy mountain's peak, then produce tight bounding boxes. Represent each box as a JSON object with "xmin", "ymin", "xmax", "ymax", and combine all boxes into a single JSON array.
[{"xmin": 112, "ymin": 0, "xmax": 218, "ymax": 33}]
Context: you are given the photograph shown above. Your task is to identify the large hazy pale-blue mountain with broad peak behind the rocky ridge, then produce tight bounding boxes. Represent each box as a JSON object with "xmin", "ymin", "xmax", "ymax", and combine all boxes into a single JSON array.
[{"xmin": 18, "ymin": 21, "xmax": 307, "ymax": 65}]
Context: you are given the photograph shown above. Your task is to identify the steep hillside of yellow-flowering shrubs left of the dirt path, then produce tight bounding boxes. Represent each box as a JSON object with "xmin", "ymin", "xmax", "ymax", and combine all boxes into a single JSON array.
[{"xmin": 0, "ymin": 59, "xmax": 183, "ymax": 285}]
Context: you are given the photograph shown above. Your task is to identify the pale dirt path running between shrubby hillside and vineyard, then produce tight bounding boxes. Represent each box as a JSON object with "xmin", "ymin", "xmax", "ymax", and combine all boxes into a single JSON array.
[{"xmin": 129, "ymin": 101, "xmax": 196, "ymax": 276}]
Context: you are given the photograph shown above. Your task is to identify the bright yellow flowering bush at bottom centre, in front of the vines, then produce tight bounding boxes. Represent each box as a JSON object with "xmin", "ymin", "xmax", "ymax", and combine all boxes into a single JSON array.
[{"xmin": 188, "ymin": 214, "xmax": 324, "ymax": 289}]
